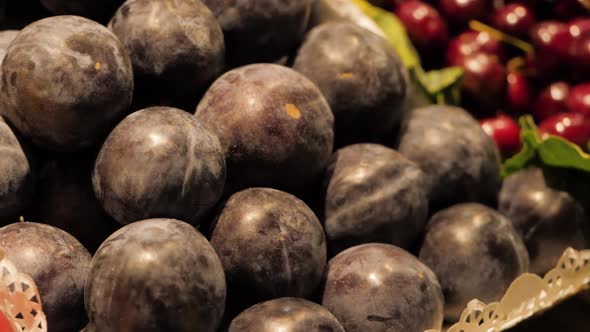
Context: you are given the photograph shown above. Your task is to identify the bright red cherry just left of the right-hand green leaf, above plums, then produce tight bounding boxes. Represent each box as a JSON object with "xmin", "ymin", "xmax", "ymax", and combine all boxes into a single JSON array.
[{"xmin": 480, "ymin": 114, "xmax": 520, "ymax": 155}]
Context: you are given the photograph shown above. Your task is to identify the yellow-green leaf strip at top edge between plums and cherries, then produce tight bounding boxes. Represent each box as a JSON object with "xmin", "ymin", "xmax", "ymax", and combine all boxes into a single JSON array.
[{"xmin": 351, "ymin": 0, "xmax": 420, "ymax": 69}]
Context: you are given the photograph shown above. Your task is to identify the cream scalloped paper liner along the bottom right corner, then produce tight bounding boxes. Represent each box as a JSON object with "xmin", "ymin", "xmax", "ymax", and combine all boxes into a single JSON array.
[{"xmin": 426, "ymin": 248, "xmax": 590, "ymax": 332}]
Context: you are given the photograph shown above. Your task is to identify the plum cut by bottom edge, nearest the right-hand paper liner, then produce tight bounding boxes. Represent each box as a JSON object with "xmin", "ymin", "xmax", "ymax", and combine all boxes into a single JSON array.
[{"xmin": 322, "ymin": 243, "xmax": 443, "ymax": 332}]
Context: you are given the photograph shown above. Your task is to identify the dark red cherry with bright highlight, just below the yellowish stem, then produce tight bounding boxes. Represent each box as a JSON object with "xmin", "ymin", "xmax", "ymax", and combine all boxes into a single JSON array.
[{"xmin": 461, "ymin": 53, "xmax": 507, "ymax": 113}]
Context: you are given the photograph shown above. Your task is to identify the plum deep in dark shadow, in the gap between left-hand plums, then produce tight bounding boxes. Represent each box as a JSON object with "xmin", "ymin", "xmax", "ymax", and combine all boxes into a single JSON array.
[{"xmin": 33, "ymin": 152, "xmax": 119, "ymax": 253}]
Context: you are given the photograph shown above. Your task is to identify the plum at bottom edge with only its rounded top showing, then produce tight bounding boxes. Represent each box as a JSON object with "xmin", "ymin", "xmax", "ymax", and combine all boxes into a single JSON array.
[{"xmin": 229, "ymin": 298, "xmax": 344, "ymax": 332}]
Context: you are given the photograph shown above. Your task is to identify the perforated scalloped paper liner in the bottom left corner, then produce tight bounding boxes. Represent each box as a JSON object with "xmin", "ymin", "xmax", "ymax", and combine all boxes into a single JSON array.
[{"xmin": 0, "ymin": 250, "xmax": 47, "ymax": 332}]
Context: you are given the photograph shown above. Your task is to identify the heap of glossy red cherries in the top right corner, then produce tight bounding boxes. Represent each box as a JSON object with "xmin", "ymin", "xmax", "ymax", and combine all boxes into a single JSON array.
[{"xmin": 389, "ymin": 0, "xmax": 590, "ymax": 154}]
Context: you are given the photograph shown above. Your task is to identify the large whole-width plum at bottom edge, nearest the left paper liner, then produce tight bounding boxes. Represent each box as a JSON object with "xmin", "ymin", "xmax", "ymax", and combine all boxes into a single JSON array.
[{"xmin": 84, "ymin": 219, "xmax": 226, "ymax": 332}]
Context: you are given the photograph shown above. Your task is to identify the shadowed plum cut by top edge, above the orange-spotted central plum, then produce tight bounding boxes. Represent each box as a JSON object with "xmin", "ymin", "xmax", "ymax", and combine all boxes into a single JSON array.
[{"xmin": 202, "ymin": 0, "xmax": 314, "ymax": 67}]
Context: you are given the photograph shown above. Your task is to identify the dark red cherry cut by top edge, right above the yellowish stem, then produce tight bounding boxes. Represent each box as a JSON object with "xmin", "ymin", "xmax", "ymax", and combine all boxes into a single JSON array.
[{"xmin": 438, "ymin": 0, "xmax": 492, "ymax": 25}]
